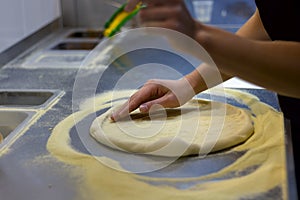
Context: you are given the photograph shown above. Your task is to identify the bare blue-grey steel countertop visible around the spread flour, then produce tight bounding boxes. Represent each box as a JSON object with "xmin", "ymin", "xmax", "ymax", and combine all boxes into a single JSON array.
[{"xmin": 0, "ymin": 29, "xmax": 295, "ymax": 199}]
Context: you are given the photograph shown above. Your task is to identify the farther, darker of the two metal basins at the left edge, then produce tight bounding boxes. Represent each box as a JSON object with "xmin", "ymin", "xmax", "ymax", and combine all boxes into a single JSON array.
[{"xmin": 0, "ymin": 90, "xmax": 64, "ymax": 108}]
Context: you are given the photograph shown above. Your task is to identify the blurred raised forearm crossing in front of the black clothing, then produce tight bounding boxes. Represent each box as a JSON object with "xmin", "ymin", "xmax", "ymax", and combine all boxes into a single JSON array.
[{"xmin": 195, "ymin": 25, "xmax": 300, "ymax": 97}]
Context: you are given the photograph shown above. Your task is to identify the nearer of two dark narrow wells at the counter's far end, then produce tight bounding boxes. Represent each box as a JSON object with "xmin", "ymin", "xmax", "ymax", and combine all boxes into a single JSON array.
[{"xmin": 51, "ymin": 41, "xmax": 98, "ymax": 50}]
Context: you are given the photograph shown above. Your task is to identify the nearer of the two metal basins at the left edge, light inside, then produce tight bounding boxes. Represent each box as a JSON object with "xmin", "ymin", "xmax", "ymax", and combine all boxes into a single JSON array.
[{"xmin": 0, "ymin": 110, "xmax": 35, "ymax": 148}]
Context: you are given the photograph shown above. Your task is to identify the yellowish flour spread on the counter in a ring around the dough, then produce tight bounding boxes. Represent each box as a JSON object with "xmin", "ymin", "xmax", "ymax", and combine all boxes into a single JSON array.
[{"xmin": 47, "ymin": 90, "xmax": 287, "ymax": 200}]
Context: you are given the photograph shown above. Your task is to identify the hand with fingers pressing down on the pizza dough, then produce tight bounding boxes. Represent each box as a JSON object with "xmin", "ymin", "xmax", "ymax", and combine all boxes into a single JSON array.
[{"xmin": 111, "ymin": 78, "xmax": 195, "ymax": 121}]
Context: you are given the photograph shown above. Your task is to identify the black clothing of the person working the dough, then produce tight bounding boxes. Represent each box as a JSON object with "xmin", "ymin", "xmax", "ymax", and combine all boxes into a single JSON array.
[{"xmin": 255, "ymin": 0, "xmax": 300, "ymax": 195}]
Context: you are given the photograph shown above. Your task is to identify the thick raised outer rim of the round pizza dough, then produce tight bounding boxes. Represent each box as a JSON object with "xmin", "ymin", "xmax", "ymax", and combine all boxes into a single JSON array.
[{"xmin": 90, "ymin": 100, "xmax": 254, "ymax": 157}]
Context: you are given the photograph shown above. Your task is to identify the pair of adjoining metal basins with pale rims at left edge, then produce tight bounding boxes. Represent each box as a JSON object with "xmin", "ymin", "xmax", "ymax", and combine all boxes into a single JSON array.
[{"xmin": 0, "ymin": 90, "xmax": 64, "ymax": 149}]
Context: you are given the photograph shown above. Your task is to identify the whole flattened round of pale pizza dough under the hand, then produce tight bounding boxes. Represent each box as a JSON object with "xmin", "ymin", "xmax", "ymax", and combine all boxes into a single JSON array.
[{"xmin": 90, "ymin": 100, "xmax": 253, "ymax": 157}]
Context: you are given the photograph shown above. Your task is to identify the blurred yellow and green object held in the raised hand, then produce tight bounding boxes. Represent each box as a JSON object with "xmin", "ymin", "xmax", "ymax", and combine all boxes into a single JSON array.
[{"xmin": 103, "ymin": 3, "xmax": 145, "ymax": 37}]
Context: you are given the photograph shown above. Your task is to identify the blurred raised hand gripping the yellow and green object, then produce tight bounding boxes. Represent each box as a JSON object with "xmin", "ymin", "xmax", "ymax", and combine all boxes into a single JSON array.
[{"xmin": 125, "ymin": 0, "xmax": 199, "ymax": 38}]
